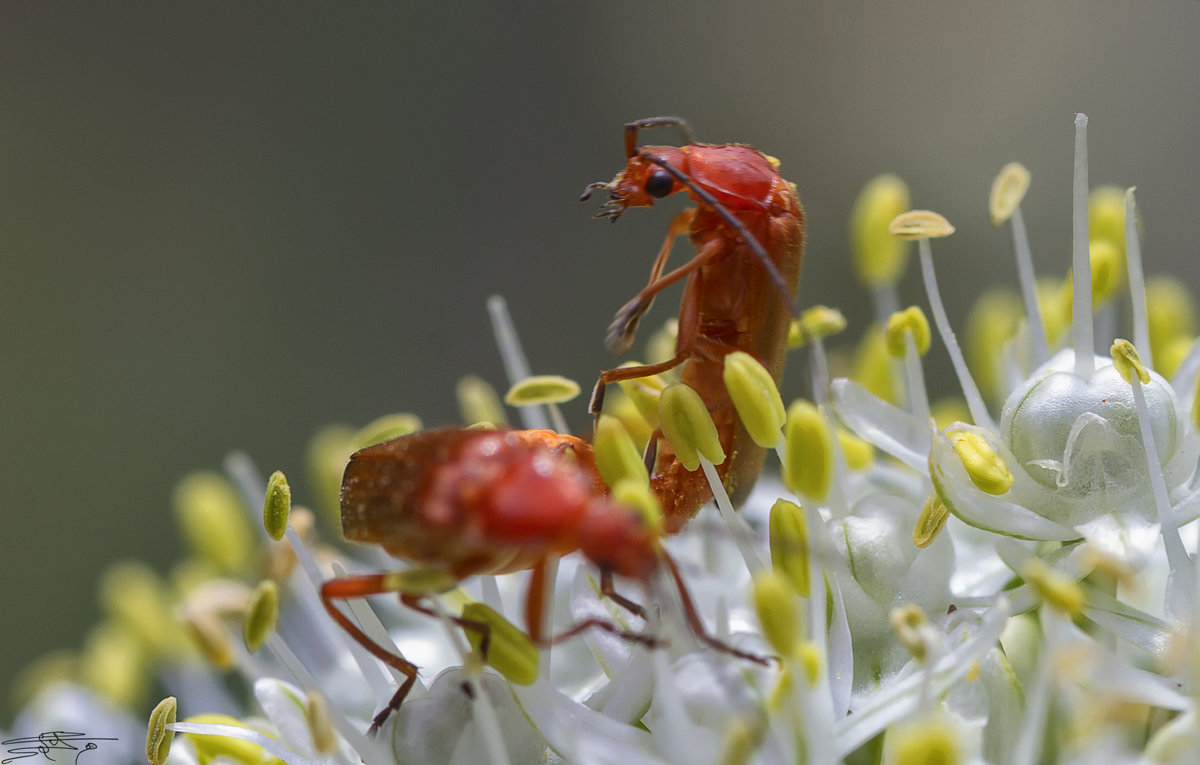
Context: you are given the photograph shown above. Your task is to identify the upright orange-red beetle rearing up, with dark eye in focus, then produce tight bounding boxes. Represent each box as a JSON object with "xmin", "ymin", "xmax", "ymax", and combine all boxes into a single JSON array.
[{"xmin": 584, "ymin": 118, "xmax": 804, "ymax": 539}]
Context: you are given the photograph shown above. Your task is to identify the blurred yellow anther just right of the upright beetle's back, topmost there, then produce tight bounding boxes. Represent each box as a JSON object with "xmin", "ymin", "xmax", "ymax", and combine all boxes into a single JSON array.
[{"xmin": 850, "ymin": 175, "xmax": 910, "ymax": 288}]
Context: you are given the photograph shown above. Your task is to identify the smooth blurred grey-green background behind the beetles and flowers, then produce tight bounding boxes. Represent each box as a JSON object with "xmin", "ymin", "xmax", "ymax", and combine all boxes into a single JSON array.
[{"xmin": 0, "ymin": 0, "xmax": 1200, "ymax": 719}]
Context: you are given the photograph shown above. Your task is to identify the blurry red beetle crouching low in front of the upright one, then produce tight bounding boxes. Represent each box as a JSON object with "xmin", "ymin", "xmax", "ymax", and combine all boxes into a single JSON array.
[{"xmin": 320, "ymin": 428, "xmax": 766, "ymax": 733}]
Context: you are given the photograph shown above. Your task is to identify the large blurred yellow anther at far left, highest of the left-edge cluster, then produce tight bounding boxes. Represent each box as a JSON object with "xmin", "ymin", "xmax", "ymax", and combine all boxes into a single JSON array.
[{"xmin": 175, "ymin": 472, "xmax": 254, "ymax": 573}]
